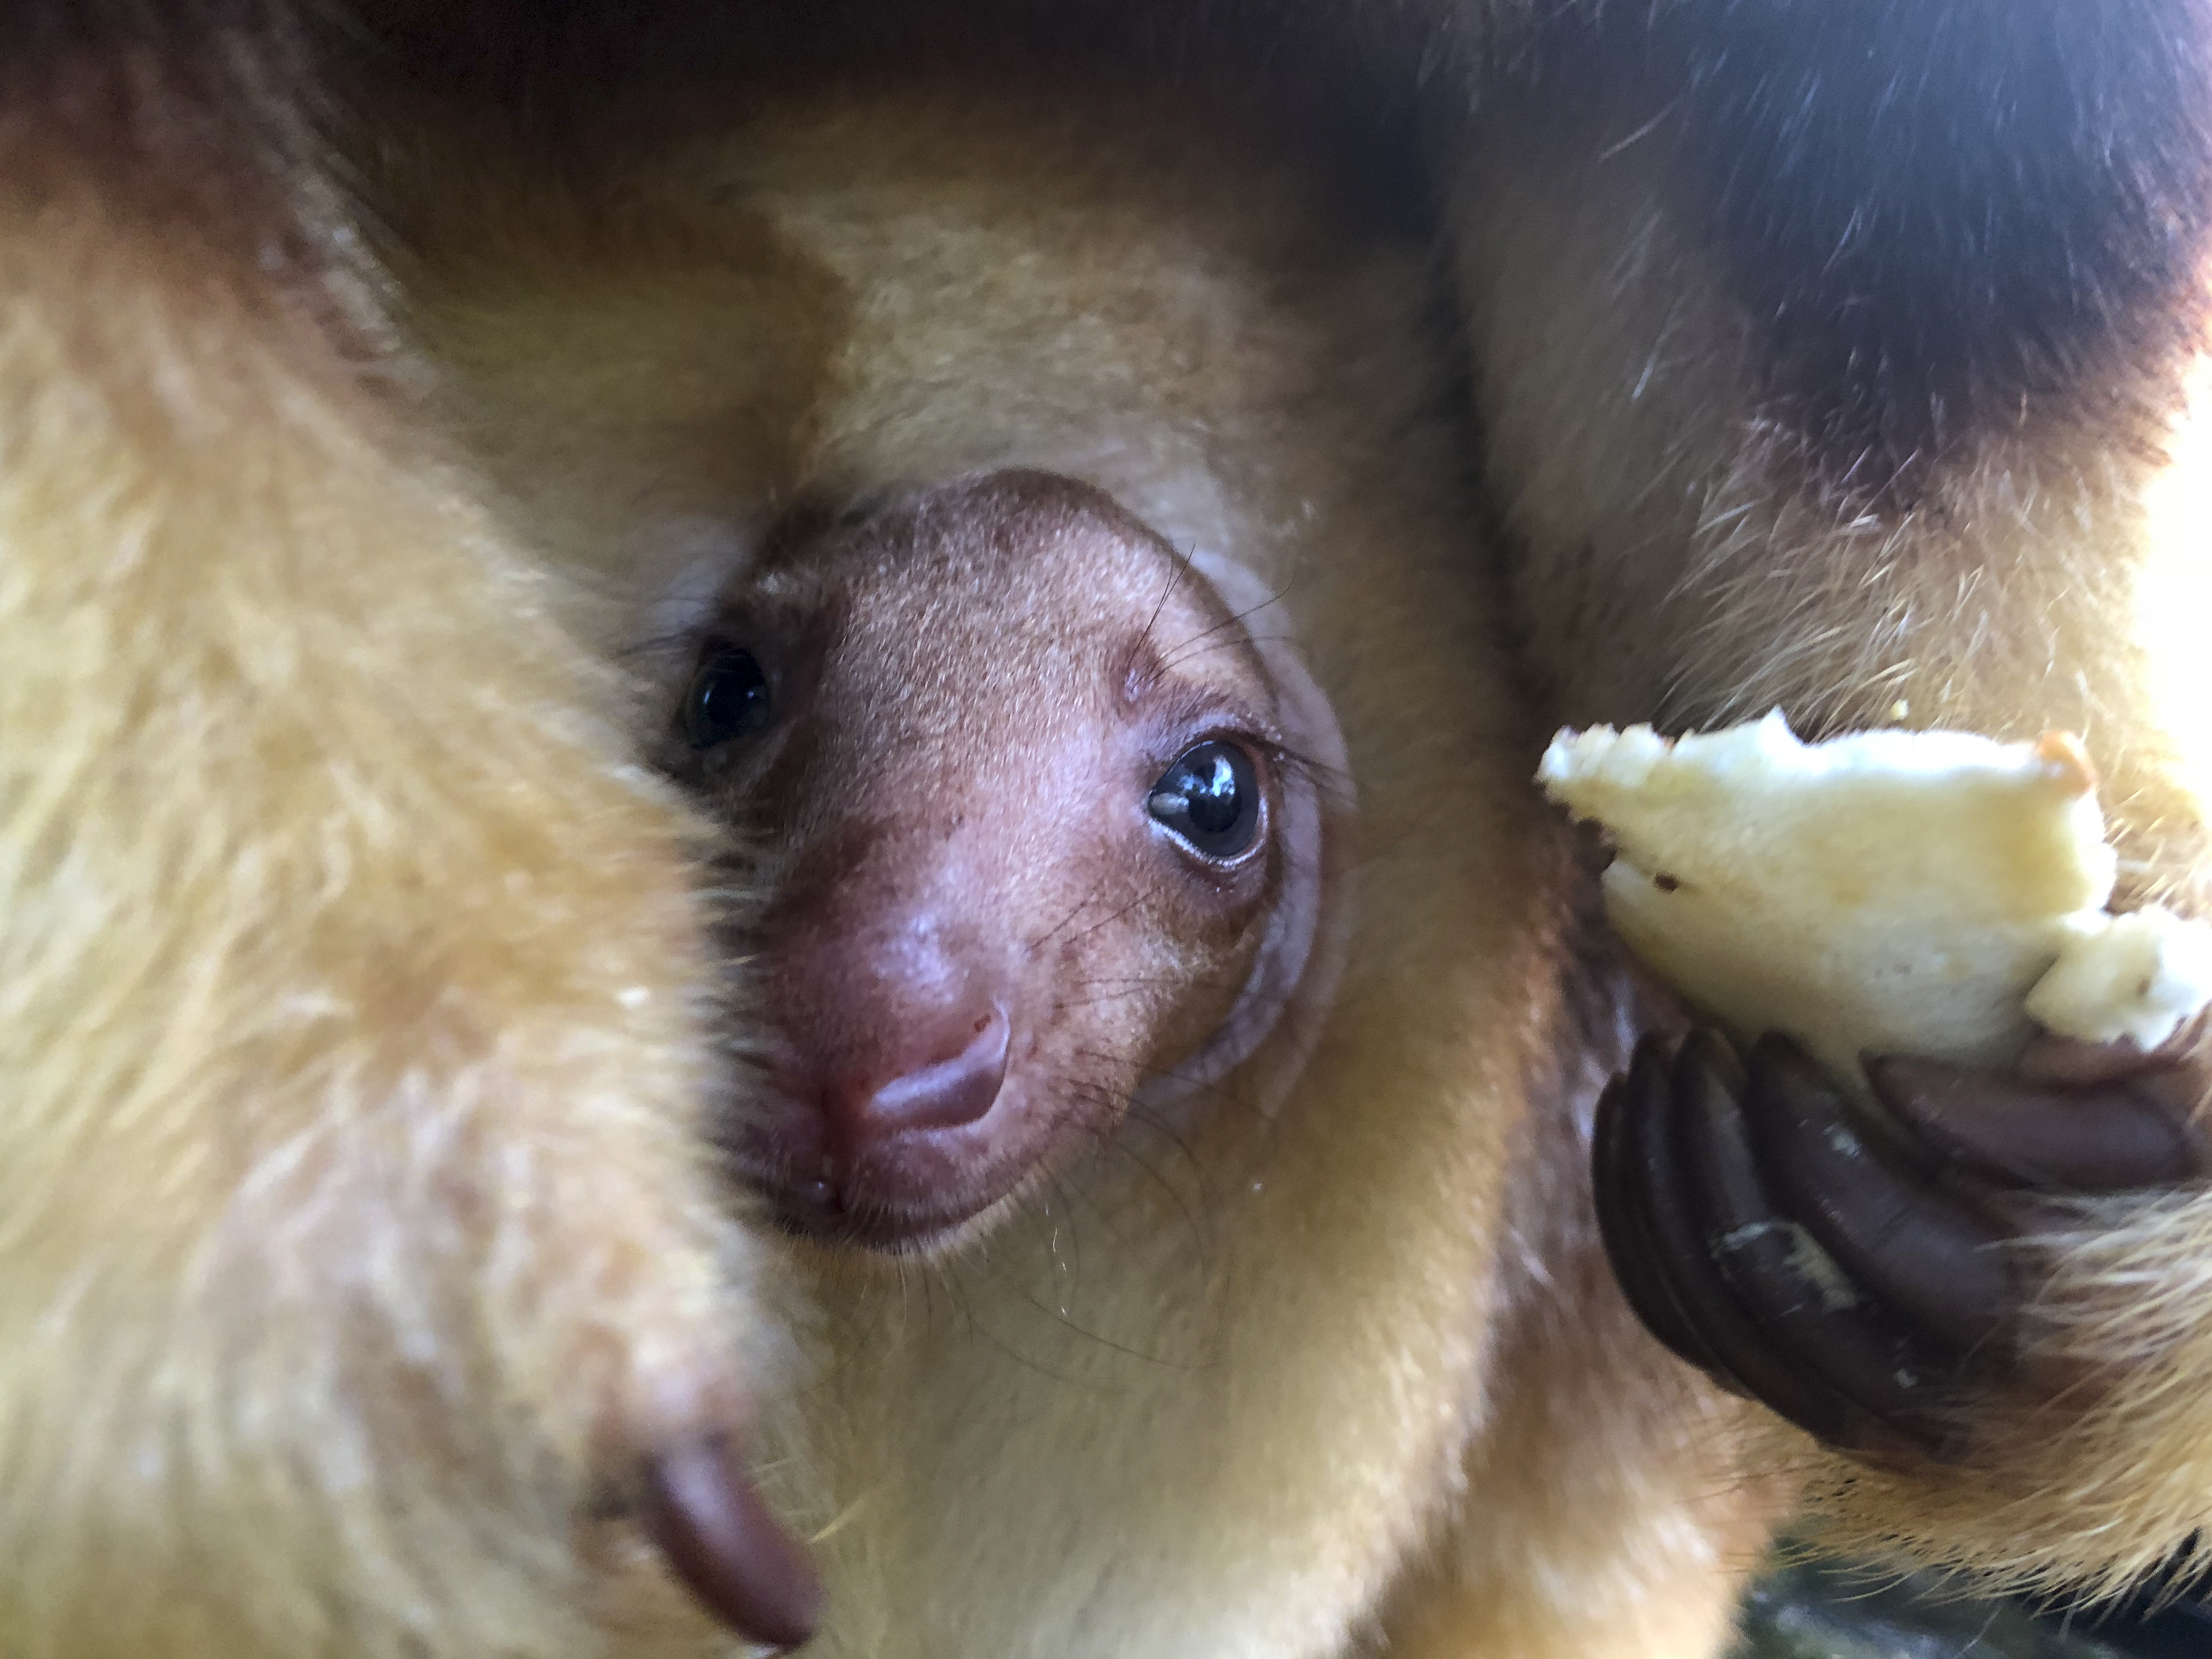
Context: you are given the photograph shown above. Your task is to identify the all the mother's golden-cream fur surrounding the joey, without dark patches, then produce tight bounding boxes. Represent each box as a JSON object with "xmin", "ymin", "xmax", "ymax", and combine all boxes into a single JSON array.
[{"xmin": 13, "ymin": 7, "xmax": 2212, "ymax": 1659}]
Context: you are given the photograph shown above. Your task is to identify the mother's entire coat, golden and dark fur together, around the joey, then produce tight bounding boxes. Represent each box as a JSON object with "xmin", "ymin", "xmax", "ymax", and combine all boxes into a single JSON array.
[{"xmin": 13, "ymin": 0, "xmax": 2212, "ymax": 1659}]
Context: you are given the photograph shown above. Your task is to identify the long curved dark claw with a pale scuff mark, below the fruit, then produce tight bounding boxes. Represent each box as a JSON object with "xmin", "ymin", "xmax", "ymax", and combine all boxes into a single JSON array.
[{"xmin": 1674, "ymin": 1033, "xmax": 1949, "ymax": 1447}]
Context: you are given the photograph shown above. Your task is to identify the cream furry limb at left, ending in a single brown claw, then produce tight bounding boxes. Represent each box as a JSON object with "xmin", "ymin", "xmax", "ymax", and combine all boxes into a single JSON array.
[{"xmin": 0, "ymin": 156, "xmax": 776, "ymax": 1659}]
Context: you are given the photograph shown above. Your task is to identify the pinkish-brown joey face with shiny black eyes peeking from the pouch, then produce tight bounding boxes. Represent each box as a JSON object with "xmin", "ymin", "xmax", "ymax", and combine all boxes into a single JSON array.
[{"xmin": 666, "ymin": 471, "xmax": 1340, "ymax": 1250}]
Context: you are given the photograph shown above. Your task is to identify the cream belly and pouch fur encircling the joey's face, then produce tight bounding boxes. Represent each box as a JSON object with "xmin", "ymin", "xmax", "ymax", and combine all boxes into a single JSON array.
[{"xmin": 389, "ymin": 93, "xmax": 1770, "ymax": 1659}]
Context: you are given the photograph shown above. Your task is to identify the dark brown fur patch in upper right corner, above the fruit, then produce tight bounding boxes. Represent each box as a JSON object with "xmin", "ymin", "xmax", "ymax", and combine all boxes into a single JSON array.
[{"xmin": 1531, "ymin": 0, "xmax": 2212, "ymax": 500}]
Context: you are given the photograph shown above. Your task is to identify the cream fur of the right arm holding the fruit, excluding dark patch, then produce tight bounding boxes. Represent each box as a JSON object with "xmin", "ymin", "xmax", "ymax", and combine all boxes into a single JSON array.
[{"xmin": 1458, "ymin": 75, "xmax": 2212, "ymax": 1586}]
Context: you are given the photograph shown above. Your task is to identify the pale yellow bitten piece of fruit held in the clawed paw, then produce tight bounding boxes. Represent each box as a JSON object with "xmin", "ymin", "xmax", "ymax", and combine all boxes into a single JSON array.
[{"xmin": 1537, "ymin": 710, "xmax": 2212, "ymax": 1080}]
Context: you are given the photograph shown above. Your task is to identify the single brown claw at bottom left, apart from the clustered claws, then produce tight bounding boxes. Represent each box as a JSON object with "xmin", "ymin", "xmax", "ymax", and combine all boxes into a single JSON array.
[{"xmin": 639, "ymin": 1436, "xmax": 823, "ymax": 1648}]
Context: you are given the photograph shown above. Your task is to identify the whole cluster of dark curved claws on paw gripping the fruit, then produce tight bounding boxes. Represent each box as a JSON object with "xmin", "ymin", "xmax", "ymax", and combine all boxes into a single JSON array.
[{"xmin": 1595, "ymin": 1031, "xmax": 2212, "ymax": 1458}]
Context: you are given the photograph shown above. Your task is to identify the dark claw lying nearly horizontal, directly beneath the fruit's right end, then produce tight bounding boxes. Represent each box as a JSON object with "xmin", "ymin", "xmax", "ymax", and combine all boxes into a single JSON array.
[{"xmin": 1867, "ymin": 1055, "xmax": 2201, "ymax": 1192}]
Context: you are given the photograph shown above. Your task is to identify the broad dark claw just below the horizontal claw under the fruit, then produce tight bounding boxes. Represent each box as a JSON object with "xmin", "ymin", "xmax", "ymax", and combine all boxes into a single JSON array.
[{"xmin": 1745, "ymin": 1035, "xmax": 2019, "ymax": 1369}]
